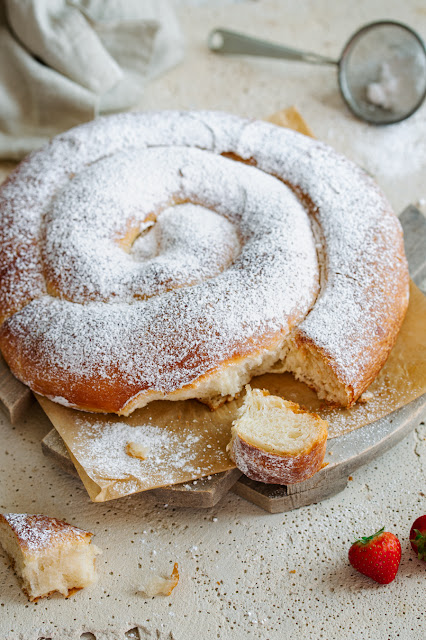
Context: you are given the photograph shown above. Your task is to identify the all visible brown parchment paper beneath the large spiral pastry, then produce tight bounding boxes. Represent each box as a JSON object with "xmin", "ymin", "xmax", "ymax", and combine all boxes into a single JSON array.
[{"xmin": 38, "ymin": 107, "xmax": 426, "ymax": 502}]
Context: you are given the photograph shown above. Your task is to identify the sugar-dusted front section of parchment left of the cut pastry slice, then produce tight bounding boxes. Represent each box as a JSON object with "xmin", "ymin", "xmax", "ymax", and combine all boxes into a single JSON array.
[{"xmin": 37, "ymin": 396, "xmax": 238, "ymax": 502}]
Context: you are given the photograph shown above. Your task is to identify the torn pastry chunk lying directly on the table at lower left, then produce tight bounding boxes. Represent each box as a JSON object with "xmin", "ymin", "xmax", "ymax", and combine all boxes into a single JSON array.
[{"xmin": 0, "ymin": 513, "xmax": 102, "ymax": 601}]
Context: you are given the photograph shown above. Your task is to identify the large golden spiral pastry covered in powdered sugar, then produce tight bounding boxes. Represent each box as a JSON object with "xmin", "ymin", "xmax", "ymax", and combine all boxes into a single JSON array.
[{"xmin": 0, "ymin": 112, "xmax": 408, "ymax": 415}]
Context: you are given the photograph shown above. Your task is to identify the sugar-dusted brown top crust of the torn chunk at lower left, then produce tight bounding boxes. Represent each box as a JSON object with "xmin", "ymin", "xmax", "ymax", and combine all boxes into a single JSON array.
[{"xmin": 1, "ymin": 513, "xmax": 91, "ymax": 552}]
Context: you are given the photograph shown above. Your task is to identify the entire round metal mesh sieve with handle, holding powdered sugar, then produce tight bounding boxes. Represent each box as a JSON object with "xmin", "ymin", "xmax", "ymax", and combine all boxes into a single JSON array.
[{"xmin": 208, "ymin": 20, "xmax": 426, "ymax": 124}]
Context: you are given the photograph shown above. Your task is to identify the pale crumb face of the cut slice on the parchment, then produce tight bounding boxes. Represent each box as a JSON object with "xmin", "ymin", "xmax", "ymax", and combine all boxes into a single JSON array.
[{"xmin": 230, "ymin": 385, "xmax": 327, "ymax": 456}]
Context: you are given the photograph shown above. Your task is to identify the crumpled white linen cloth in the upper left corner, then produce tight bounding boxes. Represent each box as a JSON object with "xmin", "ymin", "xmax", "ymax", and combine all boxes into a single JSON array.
[{"xmin": 0, "ymin": 0, "xmax": 183, "ymax": 159}]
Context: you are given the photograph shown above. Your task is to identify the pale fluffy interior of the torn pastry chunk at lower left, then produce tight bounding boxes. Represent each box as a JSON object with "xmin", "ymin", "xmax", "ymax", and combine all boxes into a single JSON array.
[{"xmin": 0, "ymin": 522, "xmax": 101, "ymax": 600}]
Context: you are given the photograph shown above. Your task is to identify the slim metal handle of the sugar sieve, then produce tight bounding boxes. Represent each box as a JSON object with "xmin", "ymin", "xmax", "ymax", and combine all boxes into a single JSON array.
[{"xmin": 207, "ymin": 29, "xmax": 339, "ymax": 65}]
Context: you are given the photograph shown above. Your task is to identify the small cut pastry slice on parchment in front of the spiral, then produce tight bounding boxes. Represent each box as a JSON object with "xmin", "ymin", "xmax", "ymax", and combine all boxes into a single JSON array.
[{"xmin": 228, "ymin": 385, "xmax": 328, "ymax": 484}]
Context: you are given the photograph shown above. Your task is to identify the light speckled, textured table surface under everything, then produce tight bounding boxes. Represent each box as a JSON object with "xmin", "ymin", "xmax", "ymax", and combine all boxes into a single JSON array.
[{"xmin": 0, "ymin": 0, "xmax": 426, "ymax": 640}]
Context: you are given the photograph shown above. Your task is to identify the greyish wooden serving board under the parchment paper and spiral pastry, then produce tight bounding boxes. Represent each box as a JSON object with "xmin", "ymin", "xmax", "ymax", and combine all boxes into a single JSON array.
[{"xmin": 0, "ymin": 206, "xmax": 426, "ymax": 513}]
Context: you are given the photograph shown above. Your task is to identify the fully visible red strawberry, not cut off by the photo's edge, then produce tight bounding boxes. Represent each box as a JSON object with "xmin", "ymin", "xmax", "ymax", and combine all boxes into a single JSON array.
[{"xmin": 349, "ymin": 528, "xmax": 401, "ymax": 584}]
